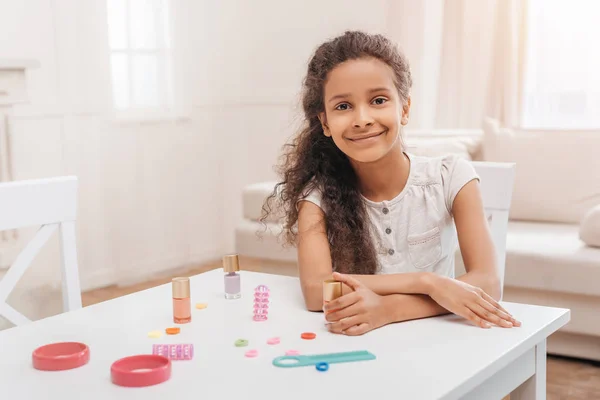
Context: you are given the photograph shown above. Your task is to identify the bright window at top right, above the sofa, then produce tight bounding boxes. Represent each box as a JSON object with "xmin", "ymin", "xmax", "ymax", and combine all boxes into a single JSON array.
[{"xmin": 522, "ymin": 0, "xmax": 600, "ymax": 129}]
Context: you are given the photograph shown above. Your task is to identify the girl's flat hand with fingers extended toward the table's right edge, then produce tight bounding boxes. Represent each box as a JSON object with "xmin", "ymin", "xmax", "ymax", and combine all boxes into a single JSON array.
[{"xmin": 429, "ymin": 276, "xmax": 521, "ymax": 328}]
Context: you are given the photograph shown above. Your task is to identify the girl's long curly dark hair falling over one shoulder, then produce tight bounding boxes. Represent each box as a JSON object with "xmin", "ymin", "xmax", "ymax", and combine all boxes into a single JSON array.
[{"xmin": 261, "ymin": 31, "xmax": 412, "ymax": 274}]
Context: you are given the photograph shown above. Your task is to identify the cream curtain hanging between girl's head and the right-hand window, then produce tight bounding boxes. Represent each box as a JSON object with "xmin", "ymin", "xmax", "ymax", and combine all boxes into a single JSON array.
[{"xmin": 388, "ymin": 0, "xmax": 527, "ymax": 129}]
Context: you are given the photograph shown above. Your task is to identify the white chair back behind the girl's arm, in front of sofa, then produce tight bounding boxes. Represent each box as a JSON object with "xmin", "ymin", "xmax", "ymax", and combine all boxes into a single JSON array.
[{"xmin": 472, "ymin": 161, "xmax": 516, "ymax": 293}]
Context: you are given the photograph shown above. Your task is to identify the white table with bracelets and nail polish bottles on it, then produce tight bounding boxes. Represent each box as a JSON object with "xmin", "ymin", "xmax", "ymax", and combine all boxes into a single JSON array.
[{"xmin": 0, "ymin": 270, "xmax": 570, "ymax": 400}]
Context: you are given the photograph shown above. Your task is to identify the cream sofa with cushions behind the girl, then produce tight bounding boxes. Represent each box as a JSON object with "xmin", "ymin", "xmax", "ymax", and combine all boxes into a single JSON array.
[{"xmin": 236, "ymin": 121, "xmax": 600, "ymax": 360}]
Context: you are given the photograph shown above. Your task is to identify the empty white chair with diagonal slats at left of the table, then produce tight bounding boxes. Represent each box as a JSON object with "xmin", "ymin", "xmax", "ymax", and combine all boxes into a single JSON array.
[{"xmin": 0, "ymin": 177, "xmax": 81, "ymax": 325}]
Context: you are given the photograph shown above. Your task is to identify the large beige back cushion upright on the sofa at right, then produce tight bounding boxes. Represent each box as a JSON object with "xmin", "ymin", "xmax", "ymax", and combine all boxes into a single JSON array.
[{"xmin": 482, "ymin": 119, "xmax": 600, "ymax": 224}]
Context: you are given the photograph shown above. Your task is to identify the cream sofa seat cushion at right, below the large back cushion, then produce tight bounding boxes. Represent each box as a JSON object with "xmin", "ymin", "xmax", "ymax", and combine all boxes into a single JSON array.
[{"xmin": 504, "ymin": 221, "xmax": 600, "ymax": 296}]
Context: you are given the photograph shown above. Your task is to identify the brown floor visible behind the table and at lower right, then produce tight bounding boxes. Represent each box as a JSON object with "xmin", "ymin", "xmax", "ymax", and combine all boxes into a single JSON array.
[{"xmin": 83, "ymin": 258, "xmax": 600, "ymax": 400}]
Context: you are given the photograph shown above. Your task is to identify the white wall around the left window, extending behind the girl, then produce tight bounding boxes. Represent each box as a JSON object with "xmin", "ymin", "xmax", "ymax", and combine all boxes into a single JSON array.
[{"xmin": 0, "ymin": 0, "xmax": 398, "ymax": 326}]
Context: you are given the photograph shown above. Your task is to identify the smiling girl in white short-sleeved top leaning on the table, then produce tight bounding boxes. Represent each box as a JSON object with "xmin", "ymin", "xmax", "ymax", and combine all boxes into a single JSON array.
[{"xmin": 263, "ymin": 32, "xmax": 520, "ymax": 335}]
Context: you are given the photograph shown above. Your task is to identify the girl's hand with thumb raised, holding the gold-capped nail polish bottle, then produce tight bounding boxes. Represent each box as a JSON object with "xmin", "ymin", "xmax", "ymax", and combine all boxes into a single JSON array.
[{"xmin": 323, "ymin": 272, "xmax": 391, "ymax": 336}]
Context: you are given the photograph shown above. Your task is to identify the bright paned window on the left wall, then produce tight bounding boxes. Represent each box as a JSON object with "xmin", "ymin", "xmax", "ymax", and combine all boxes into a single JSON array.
[{"xmin": 107, "ymin": 0, "xmax": 173, "ymax": 111}]
